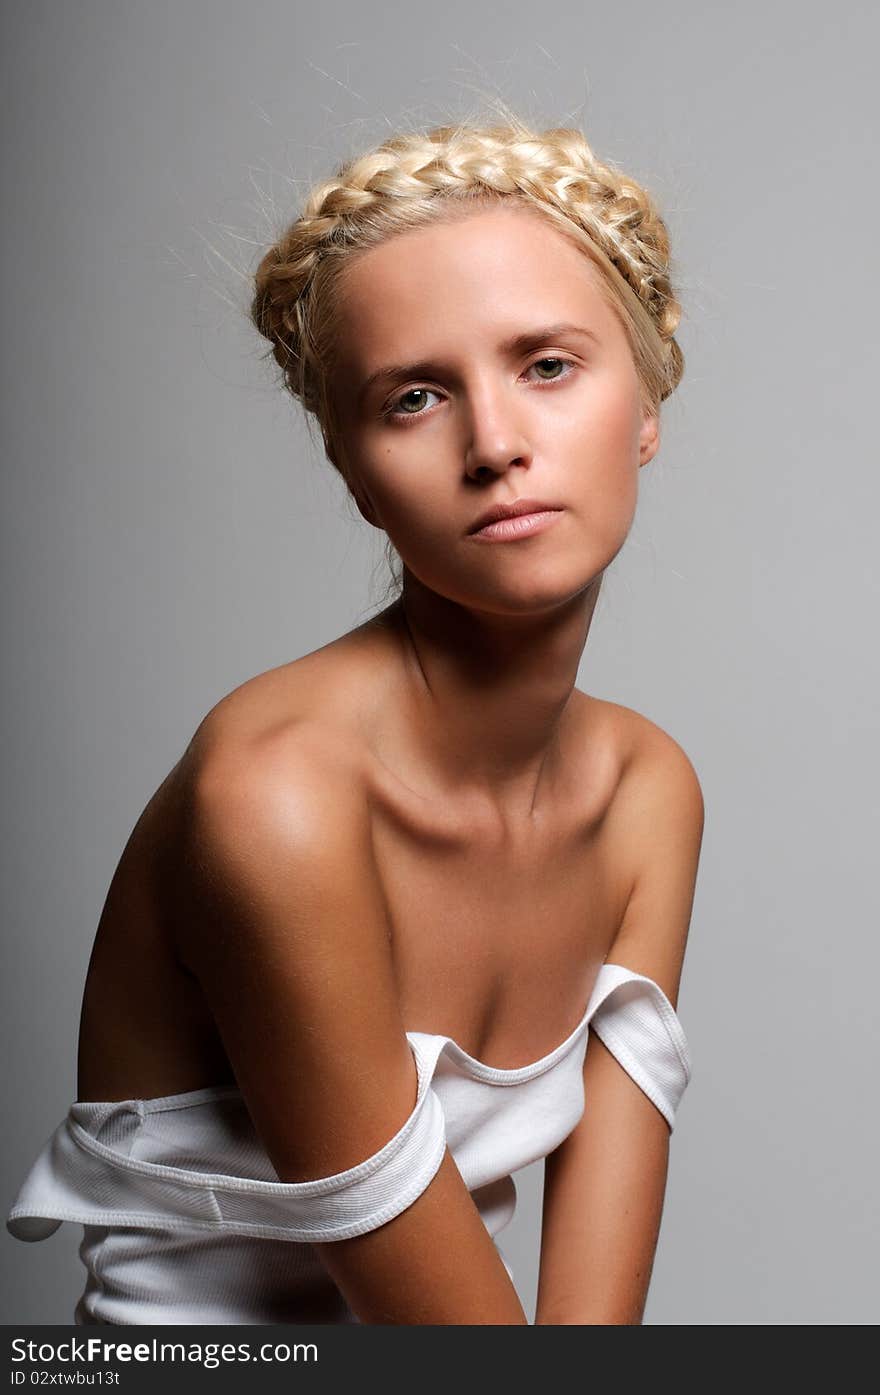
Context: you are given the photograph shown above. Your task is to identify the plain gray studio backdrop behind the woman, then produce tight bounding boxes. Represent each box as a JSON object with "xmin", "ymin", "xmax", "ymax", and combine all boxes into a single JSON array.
[{"xmin": 0, "ymin": 0, "xmax": 880, "ymax": 1324}]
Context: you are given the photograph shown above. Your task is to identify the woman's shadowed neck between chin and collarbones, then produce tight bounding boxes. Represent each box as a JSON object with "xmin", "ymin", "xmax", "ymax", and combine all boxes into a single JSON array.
[{"xmin": 384, "ymin": 571, "xmax": 601, "ymax": 820}]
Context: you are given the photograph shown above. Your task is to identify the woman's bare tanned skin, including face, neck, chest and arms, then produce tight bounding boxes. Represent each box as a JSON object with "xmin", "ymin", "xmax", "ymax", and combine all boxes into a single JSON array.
[{"xmin": 78, "ymin": 209, "xmax": 699, "ymax": 1324}]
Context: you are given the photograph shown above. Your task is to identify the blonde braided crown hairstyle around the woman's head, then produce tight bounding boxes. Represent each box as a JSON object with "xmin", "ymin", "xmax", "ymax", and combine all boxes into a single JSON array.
[{"xmin": 251, "ymin": 116, "xmax": 683, "ymax": 479}]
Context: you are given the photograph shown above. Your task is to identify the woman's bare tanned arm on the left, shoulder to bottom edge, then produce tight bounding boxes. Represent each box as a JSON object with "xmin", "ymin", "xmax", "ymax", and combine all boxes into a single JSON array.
[{"xmin": 175, "ymin": 728, "xmax": 526, "ymax": 1324}]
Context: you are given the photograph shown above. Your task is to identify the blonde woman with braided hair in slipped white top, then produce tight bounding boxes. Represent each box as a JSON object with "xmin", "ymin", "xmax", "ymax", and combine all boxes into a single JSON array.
[{"xmin": 7, "ymin": 119, "xmax": 703, "ymax": 1324}]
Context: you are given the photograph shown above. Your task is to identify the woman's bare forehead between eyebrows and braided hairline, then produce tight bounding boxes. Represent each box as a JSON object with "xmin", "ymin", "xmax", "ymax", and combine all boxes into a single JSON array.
[{"xmin": 331, "ymin": 206, "xmax": 615, "ymax": 372}]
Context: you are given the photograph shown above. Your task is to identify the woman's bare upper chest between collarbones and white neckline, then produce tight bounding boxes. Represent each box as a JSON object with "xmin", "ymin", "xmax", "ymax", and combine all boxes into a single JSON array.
[{"xmin": 362, "ymin": 708, "xmax": 632, "ymax": 1067}]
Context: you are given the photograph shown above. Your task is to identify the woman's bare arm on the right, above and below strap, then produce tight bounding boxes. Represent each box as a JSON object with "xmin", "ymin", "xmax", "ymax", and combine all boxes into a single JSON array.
[{"xmin": 536, "ymin": 735, "xmax": 703, "ymax": 1325}]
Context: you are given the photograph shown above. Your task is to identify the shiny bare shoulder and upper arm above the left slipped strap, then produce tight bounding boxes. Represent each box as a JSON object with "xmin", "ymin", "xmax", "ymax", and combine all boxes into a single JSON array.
[{"xmin": 168, "ymin": 703, "xmax": 414, "ymax": 1180}]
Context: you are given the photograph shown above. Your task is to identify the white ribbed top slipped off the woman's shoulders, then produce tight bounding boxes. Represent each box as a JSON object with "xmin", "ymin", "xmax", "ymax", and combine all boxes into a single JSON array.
[{"xmin": 6, "ymin": 964, "xmax": 692, "ymax": 1324}]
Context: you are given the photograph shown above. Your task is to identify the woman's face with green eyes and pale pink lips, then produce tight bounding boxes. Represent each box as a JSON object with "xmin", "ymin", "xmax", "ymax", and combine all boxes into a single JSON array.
[{"xmin": 331, "ymin": 208, "xmax": 658, "ymax": 614}]
